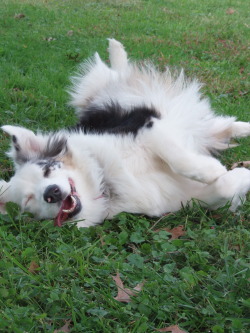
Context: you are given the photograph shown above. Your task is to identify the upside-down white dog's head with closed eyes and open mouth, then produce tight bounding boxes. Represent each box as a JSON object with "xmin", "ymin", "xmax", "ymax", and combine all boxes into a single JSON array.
[{"xmin": 0, "ymin": 126, "xmax": 82, "ymax": 226}]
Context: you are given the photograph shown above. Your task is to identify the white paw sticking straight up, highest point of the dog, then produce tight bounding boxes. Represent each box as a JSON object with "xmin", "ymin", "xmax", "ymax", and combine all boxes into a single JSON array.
[{"xmin": 108, "ymin": 38, "xmax": 128, "ymax": 72}]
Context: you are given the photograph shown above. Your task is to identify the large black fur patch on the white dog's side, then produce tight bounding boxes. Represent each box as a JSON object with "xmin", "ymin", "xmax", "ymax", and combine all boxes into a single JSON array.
[{"xmin": 76, "ymin": 102, "xmax": 160, "ymax": 136}]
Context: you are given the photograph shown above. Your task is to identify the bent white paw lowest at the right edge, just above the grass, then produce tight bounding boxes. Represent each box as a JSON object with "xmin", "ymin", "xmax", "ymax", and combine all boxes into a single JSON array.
[{"xmin": 196, "ymin": 168, "xmax": 250, "ymax": 211}]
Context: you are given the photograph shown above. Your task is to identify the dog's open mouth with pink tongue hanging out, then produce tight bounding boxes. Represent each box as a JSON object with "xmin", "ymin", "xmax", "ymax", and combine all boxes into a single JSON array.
[{"xmin": 54, "ymin": 178, "xmax": 82, "ymax": 227}]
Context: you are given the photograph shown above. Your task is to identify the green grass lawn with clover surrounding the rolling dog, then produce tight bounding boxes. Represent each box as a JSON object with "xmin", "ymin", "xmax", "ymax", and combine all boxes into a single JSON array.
[{"xmin": 0, "ymin": 0, "xmax": 250, "ymax": 333}]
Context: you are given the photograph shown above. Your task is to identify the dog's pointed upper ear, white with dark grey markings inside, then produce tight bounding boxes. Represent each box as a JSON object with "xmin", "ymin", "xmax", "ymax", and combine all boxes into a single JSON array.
[{"xmin": 2, "ymin": 125, "xmax": 44, "ymax": 167}]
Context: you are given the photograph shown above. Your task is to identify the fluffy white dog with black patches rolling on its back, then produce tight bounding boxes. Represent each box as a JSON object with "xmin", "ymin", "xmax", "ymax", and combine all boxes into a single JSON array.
[{"xmin": 0, "ymin": 39, "xmax": 250, "ymax": 227}]
